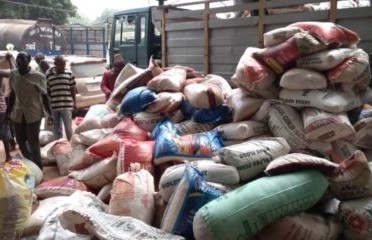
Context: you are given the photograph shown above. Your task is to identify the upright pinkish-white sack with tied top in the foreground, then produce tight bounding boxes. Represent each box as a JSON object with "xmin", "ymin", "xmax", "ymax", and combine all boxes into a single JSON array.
[{"xmin": 108, "ymin": 165, "xmax": 155, "ymax": 224}]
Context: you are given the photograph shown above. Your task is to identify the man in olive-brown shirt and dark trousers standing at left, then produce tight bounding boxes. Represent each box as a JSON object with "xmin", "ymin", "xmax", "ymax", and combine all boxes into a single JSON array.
[{"xmin": 5, "ymin": 52, "xmax": 51, "ymax": 169}]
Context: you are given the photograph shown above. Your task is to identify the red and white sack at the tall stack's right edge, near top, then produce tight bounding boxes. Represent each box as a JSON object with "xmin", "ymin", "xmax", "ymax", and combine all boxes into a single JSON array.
[{"xmin": 327, "ymin": 49, "xmax": 371, "ymax": 89}]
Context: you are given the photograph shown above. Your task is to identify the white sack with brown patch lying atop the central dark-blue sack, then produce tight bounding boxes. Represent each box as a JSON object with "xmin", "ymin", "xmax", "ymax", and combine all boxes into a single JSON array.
[{"xmin": 183, "ymin": 74, "xmax": 232, "ymax": 108}]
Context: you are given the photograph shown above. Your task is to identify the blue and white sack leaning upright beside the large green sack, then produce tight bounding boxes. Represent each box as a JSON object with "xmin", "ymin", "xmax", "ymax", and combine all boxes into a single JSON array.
[{"xmin": 161, "ymin": 164, "xmax": 222, "ymax": 239}]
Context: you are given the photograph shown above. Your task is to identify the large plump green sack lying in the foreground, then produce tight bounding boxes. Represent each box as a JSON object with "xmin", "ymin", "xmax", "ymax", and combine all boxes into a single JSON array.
[{"xmin": 193, "ymin": 170, "xmax": 328, "ymax": 240}]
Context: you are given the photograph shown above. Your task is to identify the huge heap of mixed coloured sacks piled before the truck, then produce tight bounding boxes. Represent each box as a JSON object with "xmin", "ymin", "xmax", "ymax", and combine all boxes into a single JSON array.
[{"xmin": 0, "ymin": 22, "xmax": 372, "ymax": 240}]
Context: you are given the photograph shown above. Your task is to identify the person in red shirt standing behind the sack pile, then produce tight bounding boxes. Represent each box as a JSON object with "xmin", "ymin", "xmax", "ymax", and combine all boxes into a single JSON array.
[{"xmin": 101, "ymin": 54, "xmax": 124, "ymax": 101}]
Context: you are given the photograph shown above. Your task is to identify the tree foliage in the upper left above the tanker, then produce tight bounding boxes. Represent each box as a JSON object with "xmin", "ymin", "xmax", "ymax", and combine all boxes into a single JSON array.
[{"xmin": 0, "ymin": 0, "xmax": 77, "ymax": 25}]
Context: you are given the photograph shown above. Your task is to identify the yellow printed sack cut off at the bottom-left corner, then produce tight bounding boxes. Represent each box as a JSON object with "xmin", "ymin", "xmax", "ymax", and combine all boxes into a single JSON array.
[{"xmin": 0, "ymin": 160, "xmax": 35, "ymax": 240}]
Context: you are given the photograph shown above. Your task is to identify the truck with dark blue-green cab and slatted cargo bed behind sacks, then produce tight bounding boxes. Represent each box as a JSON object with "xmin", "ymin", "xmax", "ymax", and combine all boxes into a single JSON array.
[{"xmin": 109, "ymin": 0, "xmax": 372, "ymax": 79}]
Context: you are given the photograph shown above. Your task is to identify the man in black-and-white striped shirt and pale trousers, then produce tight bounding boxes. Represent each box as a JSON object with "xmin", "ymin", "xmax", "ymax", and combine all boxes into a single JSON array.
[{"xmin": 46, "ymin": 55, "xmax": 76, "ymax": 140}]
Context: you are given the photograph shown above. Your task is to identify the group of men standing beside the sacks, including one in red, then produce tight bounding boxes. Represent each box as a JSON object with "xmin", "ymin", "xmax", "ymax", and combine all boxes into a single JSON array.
[{"xmin": 0, "ymin": 52, "xmax": 124, "ymax": 169}]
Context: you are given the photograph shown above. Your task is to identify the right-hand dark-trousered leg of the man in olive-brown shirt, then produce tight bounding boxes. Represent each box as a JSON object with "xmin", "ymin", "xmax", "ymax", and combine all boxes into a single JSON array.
[{"xmin": 26, "ymin": 120, "xmax": 43, "ymax": 169}]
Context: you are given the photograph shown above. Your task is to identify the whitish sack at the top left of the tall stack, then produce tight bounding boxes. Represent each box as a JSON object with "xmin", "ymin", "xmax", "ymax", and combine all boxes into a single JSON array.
[{"xmin": 264, "ymin": 27, "xmax": 302, "ymax": 47}]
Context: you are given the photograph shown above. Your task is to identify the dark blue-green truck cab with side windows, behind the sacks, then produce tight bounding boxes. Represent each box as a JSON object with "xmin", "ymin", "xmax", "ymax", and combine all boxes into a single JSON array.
[{"xmin": 109, "ymin": 7, "xmax": 161, "ymax": 68}]
